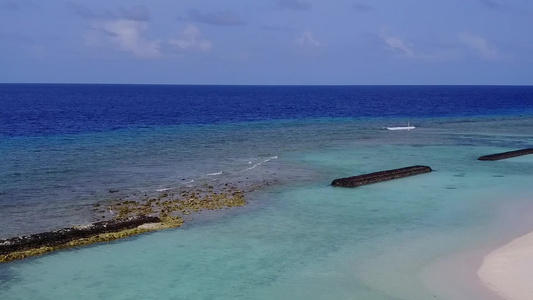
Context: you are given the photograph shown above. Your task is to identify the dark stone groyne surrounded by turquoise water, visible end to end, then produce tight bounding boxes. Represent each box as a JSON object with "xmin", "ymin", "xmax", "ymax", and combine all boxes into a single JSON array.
[{"xmin": 331, "ymin": 166, "xmax": 432, "ymax": 187}]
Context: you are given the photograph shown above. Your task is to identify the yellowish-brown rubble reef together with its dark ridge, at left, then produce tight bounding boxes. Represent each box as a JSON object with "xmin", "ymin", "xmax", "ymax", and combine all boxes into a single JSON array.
[{"xmin": 0, "ymin": 184, "xmax": 246, "ymax": 263}]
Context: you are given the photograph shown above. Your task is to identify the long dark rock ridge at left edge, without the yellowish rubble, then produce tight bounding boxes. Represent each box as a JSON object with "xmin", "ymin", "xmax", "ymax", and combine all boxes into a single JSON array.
[{"xmin": 0, "ymin": 216, "xmax": 161, "ymax": 255}]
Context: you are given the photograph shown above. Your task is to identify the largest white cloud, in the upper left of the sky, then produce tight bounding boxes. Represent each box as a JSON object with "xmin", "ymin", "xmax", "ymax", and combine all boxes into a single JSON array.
[{"xmin": 93, "ymin": 19, "xmax": 161, "ymax": 58}]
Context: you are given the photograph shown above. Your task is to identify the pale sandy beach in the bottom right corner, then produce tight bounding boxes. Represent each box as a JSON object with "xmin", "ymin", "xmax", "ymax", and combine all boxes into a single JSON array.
[{"xmin": 478, "ymin": 231, "xmax": 533, "ymax": 300}]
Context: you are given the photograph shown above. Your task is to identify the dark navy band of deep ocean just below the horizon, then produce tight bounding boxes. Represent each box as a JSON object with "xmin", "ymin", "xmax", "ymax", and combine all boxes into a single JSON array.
[{"xmin": 0, "ymin": 84, "xmax": 533, "ymax": 137}]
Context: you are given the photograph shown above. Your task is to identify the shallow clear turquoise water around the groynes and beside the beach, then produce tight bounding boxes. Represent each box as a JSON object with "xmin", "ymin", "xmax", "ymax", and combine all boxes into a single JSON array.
[{"xmin": 0, "ymin": 118, "xmax": 533, "ymax": 300}]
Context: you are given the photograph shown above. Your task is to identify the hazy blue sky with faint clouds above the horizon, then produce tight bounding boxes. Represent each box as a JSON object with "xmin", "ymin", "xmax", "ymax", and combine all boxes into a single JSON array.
[{"xmin": 0, "ymin": 0, "xmax": 533, "ymax": 85}]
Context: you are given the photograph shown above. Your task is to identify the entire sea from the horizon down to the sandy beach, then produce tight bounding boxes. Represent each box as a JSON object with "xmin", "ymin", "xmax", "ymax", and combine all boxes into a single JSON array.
[{"xmin": 0, "ymin": 84, "xmax": 533, "ymax": 300}]
